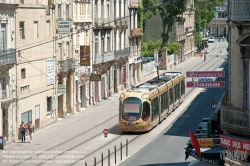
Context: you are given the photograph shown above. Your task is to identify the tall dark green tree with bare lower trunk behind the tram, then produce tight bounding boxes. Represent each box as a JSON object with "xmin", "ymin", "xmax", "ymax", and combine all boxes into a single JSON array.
[{"xmin": 159, "ymin": 0, "xmax": 187, "ymax": 45}]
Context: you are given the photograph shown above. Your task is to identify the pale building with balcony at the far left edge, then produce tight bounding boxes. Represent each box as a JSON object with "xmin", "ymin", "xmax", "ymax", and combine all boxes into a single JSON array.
[{"xmin": 0, "ymin": 0, "xmax": 18, "ymax": 142}]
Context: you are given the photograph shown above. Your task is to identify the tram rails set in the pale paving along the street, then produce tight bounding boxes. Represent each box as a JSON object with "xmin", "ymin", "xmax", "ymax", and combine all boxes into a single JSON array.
[{"xmin": 15, "ymin": 42, "xmax": 228, "ymax": 165}]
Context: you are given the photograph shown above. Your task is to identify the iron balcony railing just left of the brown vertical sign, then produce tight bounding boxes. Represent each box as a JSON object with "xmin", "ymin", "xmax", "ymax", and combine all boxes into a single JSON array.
[{"xmin": 58, "ymin": 59, "xmax": 76, "ymax": 73}]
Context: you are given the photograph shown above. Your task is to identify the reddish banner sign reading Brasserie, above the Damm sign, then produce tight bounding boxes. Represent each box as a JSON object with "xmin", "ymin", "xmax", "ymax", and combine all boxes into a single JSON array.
[{"xmin": 186, "ymin": 71, "xmax": 225, "ymax": 77}]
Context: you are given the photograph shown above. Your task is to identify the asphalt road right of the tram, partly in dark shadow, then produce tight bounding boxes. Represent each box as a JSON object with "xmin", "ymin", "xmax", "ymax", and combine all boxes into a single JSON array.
[{"xmin": 119, "ymin": 40, "xmax": 228, "ymax": 166}]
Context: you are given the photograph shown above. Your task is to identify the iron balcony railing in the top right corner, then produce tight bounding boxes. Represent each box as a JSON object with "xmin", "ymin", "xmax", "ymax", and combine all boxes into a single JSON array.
[{"xmin": 230, "ymin": 0, "xmax": 250, "ymax": 21}]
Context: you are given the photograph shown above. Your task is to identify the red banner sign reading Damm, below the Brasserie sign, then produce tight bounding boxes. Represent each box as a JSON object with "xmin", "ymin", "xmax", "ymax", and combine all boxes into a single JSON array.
[{"xmin": 186, "ymin": 81, "xmax": 225, "ymax": 88}]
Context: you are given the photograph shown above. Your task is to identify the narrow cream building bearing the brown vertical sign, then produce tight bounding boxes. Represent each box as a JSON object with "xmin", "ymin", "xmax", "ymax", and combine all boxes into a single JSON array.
[{"xmin": 72, "ymin": 0, "xmax": 94, "ymax": 108}]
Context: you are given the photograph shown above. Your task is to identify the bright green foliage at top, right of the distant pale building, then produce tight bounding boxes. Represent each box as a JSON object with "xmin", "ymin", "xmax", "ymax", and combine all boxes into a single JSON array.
[{"xmin": 194, "ymin": 0, "xmax": 226, "ymax": 32}]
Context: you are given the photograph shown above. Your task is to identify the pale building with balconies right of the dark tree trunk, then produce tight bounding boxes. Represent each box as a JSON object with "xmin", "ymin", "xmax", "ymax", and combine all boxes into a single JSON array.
[{"xmin": 172, "ymin": 0, "xmax": 195, "ymax": 64}]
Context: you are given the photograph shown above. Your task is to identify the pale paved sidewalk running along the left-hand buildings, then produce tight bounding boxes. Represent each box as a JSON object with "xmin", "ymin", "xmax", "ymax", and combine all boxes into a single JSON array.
[{"xmin": 0, "ymin": 41, "xmax": 225, "ymax": 165}]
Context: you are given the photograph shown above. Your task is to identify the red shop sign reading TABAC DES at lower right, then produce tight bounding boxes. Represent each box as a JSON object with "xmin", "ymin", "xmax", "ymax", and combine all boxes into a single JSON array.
[{"xmin": 220, "ymin": 135, "xmax": 250, "ymax": 152}]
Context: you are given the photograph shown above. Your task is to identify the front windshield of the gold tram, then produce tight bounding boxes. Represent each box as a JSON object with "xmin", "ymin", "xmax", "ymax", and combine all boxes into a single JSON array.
[{"xmin": 122, "ymin": 97, "xmax": 142, "ymax": 121}]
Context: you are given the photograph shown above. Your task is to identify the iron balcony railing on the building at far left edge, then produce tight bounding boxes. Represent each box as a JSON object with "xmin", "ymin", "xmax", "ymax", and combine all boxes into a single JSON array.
[{"xmin": 0, "ymin": 49, "xmax": 16, "ymax": 66}]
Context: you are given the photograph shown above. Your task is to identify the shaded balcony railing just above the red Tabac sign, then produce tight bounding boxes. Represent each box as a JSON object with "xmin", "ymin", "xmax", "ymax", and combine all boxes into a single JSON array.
[{"xmin": 220, "ymin": 105, "xmax": 250, "ymax": 137}]
